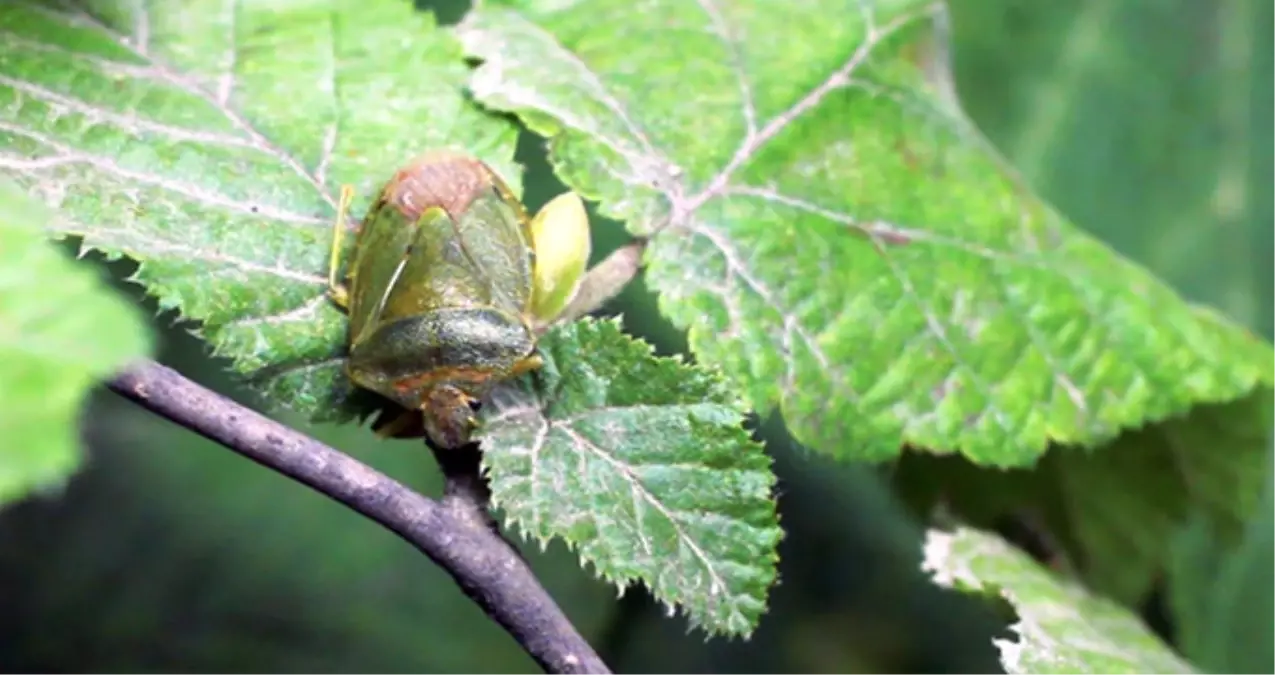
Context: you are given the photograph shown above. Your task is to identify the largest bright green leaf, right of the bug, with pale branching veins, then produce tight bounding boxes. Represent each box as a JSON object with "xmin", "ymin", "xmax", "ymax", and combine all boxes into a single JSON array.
[{"xmin": 460, "ymin": 0, "xmax": 1275, "ymax": 466}]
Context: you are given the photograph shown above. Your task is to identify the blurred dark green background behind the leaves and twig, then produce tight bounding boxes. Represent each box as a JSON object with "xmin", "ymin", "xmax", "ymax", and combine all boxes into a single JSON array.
[{"xmin": 0, "ymin": 0, "xmax": 1275, "ymax": 674}]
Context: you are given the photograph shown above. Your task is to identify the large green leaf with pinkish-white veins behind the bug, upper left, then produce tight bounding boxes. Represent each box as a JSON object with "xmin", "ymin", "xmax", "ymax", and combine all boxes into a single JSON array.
[{"xmin": 0, "ymin": 0, "xmax": 519, "ymax": 417}]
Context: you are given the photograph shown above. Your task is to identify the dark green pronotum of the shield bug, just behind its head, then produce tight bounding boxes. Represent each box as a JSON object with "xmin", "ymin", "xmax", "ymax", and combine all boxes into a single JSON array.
[{"xmin": 349, "ymin": 308, "xmax": 536, "ymax": 408}]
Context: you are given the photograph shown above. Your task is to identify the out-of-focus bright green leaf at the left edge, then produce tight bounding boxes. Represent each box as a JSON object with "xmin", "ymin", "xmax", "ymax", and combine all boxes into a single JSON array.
[{"xmin": 0, "ymin": 180, "xmax": 150, "ymax": 505}]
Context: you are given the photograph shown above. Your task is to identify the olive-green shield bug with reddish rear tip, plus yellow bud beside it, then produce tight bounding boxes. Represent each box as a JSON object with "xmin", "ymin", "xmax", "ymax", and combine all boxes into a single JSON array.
[{"xmin": 329, "ymin": 152, "xmax": 589, "ymax": 449}]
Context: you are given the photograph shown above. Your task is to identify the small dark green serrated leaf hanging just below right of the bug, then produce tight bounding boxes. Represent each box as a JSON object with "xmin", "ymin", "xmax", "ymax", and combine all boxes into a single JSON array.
[{"xmin": 482, "ymin": 320, "xmax": 782, "ymax": 635}]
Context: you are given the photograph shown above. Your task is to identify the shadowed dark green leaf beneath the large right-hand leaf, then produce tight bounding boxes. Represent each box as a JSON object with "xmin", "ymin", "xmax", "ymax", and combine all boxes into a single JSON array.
[{"xmin": 891, "ymin": 397, "xmax": 1267, "ymax": 606}]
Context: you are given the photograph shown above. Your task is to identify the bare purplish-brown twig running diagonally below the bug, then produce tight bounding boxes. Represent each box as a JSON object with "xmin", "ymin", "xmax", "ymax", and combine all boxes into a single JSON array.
[{"xmin": 110, "ymin": 361, "xmax": 611, "ymax": 675}]
